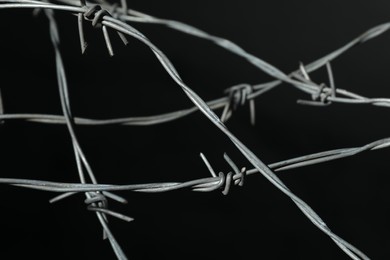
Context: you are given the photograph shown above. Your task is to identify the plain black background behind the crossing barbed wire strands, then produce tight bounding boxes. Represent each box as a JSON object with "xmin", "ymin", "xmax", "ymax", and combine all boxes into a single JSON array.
[{"xmin": 0, "ymin": 0, "xmax": 390, "ymax": 259}]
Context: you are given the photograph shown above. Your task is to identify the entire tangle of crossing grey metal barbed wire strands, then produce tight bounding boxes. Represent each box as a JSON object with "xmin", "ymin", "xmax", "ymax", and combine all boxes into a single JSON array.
[{"xmin": 0, "ymin": 0, "xmax": 390, "ymax": 259}]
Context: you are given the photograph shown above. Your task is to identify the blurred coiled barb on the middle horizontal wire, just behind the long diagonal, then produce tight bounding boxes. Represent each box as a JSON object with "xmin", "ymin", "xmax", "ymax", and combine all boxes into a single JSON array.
[{"xmin": 221, "ymin": 84, "xmax": 255, "ymax": 125}]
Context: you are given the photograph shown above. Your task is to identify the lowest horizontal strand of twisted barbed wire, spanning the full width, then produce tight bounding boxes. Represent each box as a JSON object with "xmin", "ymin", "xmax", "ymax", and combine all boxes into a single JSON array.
[{"xmin": 5, "ymin": 135, "xmax": 390, "ymax": 192}]
